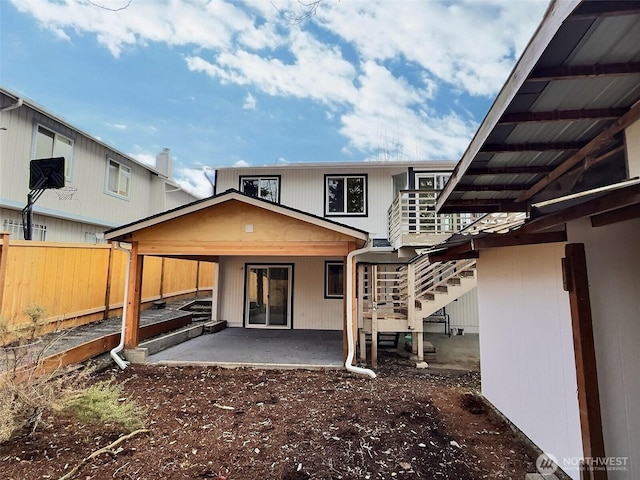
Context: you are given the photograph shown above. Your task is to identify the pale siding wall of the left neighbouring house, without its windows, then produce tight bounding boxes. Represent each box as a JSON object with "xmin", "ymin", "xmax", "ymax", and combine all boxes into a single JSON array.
[{"xmin": 0, "ymin": 88, "xmax": 195, "ymax": 242}]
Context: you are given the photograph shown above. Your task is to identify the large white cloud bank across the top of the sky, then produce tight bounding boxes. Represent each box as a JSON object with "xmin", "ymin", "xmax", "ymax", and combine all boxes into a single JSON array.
[{"xmin": 11, "ymin": 0, "xmax": 547, "ymax": 162}]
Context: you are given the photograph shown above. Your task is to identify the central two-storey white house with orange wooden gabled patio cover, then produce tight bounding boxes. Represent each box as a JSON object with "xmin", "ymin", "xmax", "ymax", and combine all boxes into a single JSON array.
[{"xmin": 105, "ymin": 162, "xmax": 475, "ymax": 364}]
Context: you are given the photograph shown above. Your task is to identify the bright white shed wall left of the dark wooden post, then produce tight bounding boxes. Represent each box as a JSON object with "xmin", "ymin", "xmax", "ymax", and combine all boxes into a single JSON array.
[{"xmin": 477, "ymin": 244, "xmax": 582, "ymax": 480}]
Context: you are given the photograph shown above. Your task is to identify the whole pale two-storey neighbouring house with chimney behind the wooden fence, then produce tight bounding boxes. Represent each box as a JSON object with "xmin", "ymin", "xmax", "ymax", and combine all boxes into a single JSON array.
[{"xmin": 0, "ymin": 88, "xmax": 196, "ymax": 243}]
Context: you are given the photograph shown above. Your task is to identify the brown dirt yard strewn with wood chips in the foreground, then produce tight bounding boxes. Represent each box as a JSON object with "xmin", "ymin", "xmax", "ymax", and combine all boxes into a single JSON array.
[{"xmin": 0, "ymin": 357, "xmax": 536, "ymax": 480}]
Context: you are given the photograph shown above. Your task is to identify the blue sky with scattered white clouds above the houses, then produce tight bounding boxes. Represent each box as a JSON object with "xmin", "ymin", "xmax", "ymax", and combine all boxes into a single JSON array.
[{"xmin": 0, "ymin": 0, "xmax": 548, "ymax": 196}]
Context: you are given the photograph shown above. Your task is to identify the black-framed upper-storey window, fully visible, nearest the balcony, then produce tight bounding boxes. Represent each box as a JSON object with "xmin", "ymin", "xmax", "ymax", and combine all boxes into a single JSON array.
[{"xmin": 324, "ymin": 175, "xmax": 367, "ymax": 216}]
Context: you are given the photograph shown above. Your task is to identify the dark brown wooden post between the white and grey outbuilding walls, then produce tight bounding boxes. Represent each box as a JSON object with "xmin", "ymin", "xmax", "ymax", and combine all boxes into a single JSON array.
[{"xmin": 563, "ymin": 243, "xmax": 607, "ymax": 480}]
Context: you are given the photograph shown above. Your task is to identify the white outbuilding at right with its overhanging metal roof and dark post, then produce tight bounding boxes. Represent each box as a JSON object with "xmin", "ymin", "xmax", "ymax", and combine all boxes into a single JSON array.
[{"xmin": 429, "ymin": 0, "xmax": 640, "ymax": 479}]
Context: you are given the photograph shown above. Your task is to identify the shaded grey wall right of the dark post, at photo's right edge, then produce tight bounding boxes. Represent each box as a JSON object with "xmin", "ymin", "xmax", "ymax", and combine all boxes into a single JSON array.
[{"xmin": 567, "ymin": 218, "xmax": 640, "ymax": 480}]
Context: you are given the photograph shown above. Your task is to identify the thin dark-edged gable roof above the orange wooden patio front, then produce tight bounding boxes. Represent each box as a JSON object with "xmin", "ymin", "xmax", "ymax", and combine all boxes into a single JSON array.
[{"xmin": 104, "ymin": 189, "xmax": 369, "ymax": 241}]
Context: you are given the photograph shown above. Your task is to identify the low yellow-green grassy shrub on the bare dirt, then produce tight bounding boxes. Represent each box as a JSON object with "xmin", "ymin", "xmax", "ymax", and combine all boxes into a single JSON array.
[{"xmin": 63, "ymin": 381, "xmax": 145, "ymax": 433}]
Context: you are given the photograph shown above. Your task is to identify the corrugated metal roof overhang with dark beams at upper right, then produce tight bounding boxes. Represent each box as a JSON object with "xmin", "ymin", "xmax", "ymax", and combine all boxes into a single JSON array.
[{"xmin": 436, "ymin": 0, "xmax": 640, "ymax": 213}]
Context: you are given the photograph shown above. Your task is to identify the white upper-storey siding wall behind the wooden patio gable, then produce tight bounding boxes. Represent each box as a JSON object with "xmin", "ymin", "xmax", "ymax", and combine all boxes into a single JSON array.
[{"xmin": 216, "ymin": 162, "xmax": 454, "ymax": 238}]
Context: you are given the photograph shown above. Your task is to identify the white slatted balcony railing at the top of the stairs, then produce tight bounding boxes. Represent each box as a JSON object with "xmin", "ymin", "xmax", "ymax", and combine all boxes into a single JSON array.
[{"xmin": 387, "ymin": 190, "xmax": 478, "ymax": 247}]
